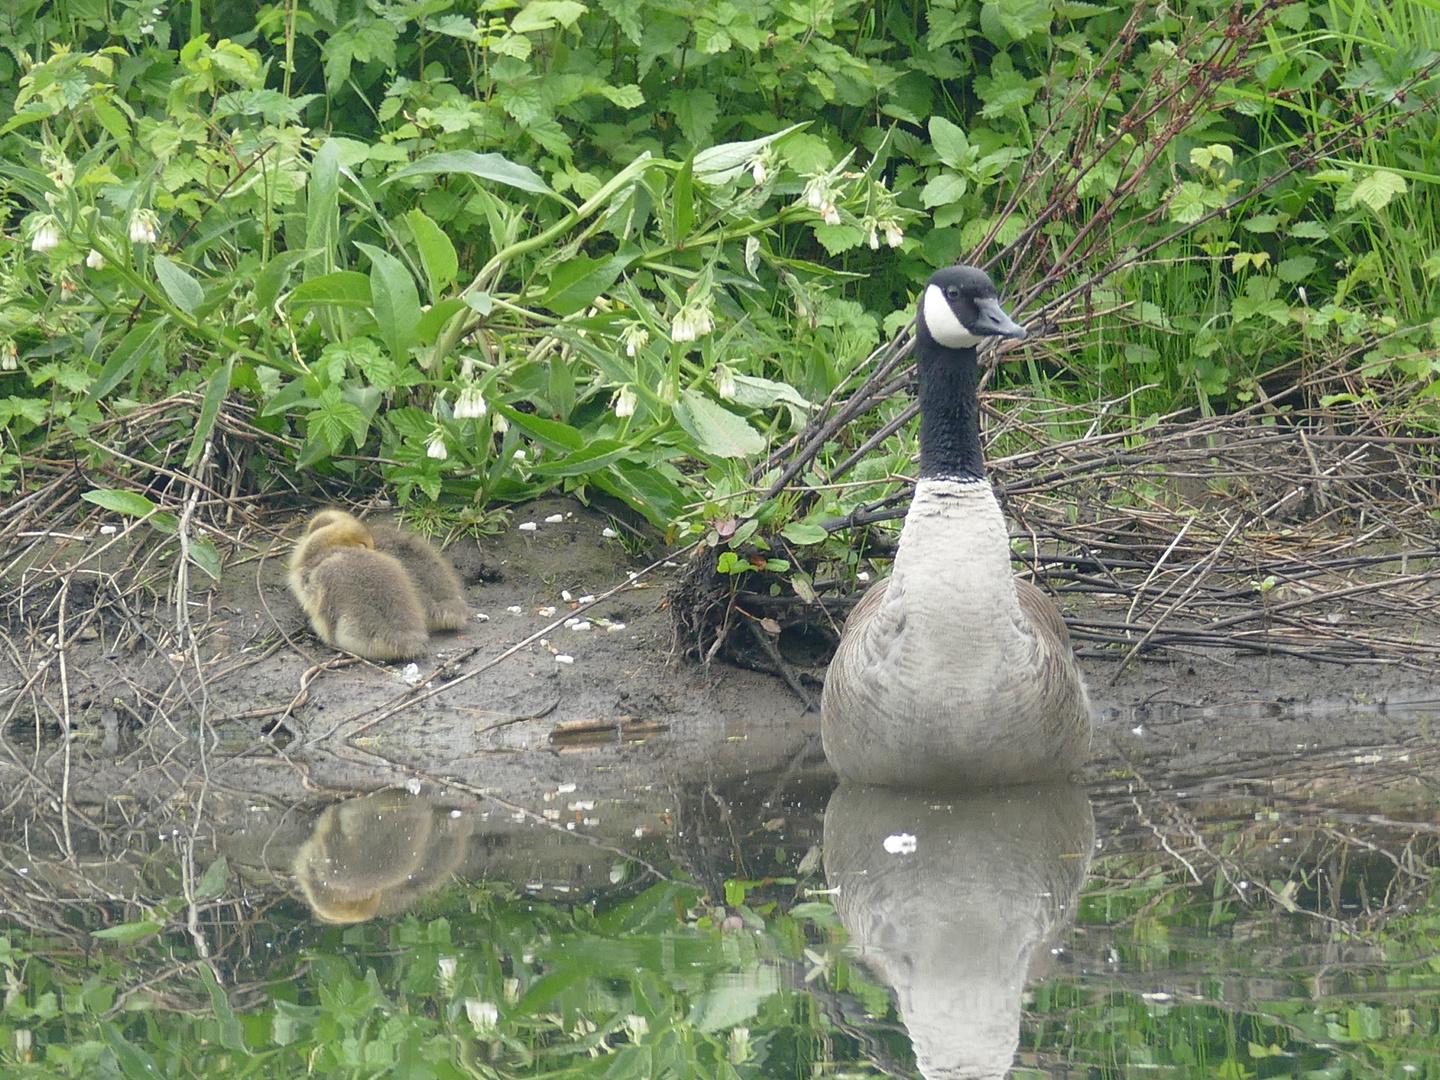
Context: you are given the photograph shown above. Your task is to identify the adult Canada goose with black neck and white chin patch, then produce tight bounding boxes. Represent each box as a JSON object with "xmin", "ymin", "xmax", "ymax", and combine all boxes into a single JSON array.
[{"xmin": 821, "ymin": 266, "xmax": 1090, "ymax": 788}]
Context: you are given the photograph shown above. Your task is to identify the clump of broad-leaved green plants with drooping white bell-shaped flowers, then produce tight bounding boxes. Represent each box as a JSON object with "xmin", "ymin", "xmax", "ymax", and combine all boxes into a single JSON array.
[{"xmin": 0, "ymin": 31, "xmax": 914, "ymax": 526}]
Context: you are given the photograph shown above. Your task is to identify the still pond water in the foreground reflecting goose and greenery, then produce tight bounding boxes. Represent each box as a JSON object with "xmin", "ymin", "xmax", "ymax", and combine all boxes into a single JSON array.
[{"xmin": 0, "ymin": 713, "xmax": 1440, "ymax": 1080}]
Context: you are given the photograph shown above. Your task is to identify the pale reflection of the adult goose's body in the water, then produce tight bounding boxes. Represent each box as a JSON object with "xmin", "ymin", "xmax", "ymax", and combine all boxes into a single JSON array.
[{"xmin": 825, "ymin": 785, "xmax": 1094, "ymax": 1080}]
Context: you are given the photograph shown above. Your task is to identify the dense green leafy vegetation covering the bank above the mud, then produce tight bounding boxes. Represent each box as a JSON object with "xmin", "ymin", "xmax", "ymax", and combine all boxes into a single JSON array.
[{"xmin": 0, "ymin": 0, "xmax": 1440, "ymax": 558}]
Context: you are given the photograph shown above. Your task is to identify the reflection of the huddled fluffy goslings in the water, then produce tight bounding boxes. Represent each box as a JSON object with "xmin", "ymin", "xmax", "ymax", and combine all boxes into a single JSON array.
[{"xmin": 295, "ymin": 792, "xmax": 474, "ymax": 923}]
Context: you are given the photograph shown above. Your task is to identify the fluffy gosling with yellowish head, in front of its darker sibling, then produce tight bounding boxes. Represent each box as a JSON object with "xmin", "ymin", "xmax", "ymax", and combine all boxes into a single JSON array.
[{"xmin": 289, "ymin": 510, "xmax": 429, "ymax": 660}]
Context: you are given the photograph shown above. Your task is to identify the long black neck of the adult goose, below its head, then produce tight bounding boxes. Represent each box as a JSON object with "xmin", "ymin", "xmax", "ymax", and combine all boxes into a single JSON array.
[{"xmin": 916, "ymin": 333, "xmax": 985, "ymax": 480}]
